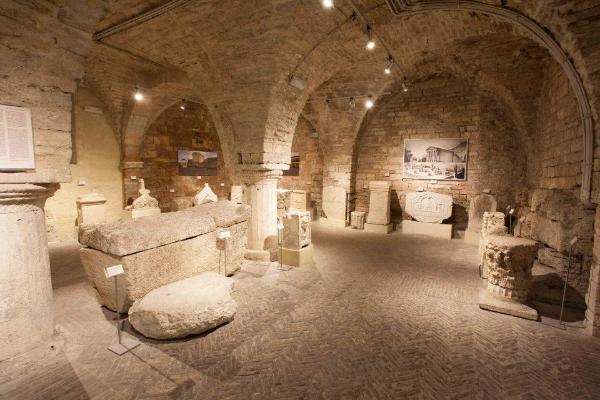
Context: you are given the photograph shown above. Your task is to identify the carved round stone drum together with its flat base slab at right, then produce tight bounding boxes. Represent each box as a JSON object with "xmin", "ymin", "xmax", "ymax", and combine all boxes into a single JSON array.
[{"xmin": 479, "ymin": 235, "xmax": 538, "ymax": 320}]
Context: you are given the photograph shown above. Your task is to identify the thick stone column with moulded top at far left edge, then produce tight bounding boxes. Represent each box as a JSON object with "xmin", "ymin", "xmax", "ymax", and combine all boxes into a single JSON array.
[{"xmin": 0, "ymin": 184, "xmax": 54, "ymax": 361}]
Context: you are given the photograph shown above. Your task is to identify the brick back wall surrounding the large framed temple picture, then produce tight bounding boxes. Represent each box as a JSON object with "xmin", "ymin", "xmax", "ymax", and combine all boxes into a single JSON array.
[{"xmin": 356, "ymin": 78, "xmax": 525, "ymax": 230}]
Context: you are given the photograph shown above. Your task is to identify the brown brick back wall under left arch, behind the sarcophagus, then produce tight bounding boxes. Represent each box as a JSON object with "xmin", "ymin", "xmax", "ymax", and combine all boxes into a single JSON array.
[{"xmin": 142, "ymin": 102, "xmax": 231, "ymax": 212}]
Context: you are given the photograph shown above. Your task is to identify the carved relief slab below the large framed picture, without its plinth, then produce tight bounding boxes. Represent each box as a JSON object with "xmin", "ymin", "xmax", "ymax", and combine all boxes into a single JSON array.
[{"xmin": 406, "ymin": 192, "xmax": 452, "ymax": 224}]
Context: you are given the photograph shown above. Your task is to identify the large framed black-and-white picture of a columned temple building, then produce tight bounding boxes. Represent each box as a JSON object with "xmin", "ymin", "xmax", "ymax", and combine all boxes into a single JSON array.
[{"xmin": 402, "ymin": 139, "xmax": 469, "ymax": 181}]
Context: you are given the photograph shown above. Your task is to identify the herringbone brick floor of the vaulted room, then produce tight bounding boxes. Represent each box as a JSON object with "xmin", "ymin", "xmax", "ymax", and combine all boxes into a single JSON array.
[{"xmin": 0, "ymin": 226, "xmax": 600, "ymax": 400}]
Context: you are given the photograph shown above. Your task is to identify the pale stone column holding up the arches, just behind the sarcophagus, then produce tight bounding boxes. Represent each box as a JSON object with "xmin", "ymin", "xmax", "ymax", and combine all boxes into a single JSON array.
[{"xmin": 244, "ymin": 174, "xmax": 278, "ymax": 261}]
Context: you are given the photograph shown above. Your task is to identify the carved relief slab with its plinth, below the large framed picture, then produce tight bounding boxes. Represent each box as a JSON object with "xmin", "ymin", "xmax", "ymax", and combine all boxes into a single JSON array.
[{"xmin": 402, "ymin": 192, "xmax": 452, "ymax": 239}]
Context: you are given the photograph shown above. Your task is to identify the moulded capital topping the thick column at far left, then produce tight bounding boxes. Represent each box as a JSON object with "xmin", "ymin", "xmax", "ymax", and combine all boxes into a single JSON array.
[{"xmin": 0, "ymin": 183, "xmax": 51, "ymax": 214}]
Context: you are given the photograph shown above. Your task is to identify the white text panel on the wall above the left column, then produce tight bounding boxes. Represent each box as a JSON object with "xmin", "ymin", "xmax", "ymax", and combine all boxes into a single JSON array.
[{"xmin": 0, "ymin": 105, "xmax": 35, "ymax": 171}]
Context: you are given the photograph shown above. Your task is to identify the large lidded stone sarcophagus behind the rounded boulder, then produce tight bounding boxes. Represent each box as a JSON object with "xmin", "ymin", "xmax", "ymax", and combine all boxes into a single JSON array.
[{"xmin": 79, "ymin": 200, "xmax": 250, "ymax": 311}]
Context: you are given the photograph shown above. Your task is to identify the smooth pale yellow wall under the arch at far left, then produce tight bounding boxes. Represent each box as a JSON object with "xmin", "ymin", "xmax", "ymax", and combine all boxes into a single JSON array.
[{"xmin": 46, "ymin": 88, "xmax": 123, "ymax": 241}]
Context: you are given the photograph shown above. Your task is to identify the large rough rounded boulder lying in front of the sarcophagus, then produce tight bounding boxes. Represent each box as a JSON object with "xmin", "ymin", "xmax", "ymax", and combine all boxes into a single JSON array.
[{"xmin": 129, "ymin": 272, "xmax": 237, "ymax": 339}]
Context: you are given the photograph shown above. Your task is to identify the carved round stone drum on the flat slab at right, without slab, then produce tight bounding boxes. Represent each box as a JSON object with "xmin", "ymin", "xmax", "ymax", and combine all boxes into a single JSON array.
[{"xmin": 485, "ymin": 235, "xmax": 538, "ymax": 302}]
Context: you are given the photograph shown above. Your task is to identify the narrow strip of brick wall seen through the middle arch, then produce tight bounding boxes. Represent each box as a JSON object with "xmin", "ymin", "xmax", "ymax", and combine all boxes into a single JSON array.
[{"xmin": 279, "ymin": 116, "xmax": 323, "ymax": 216}]
